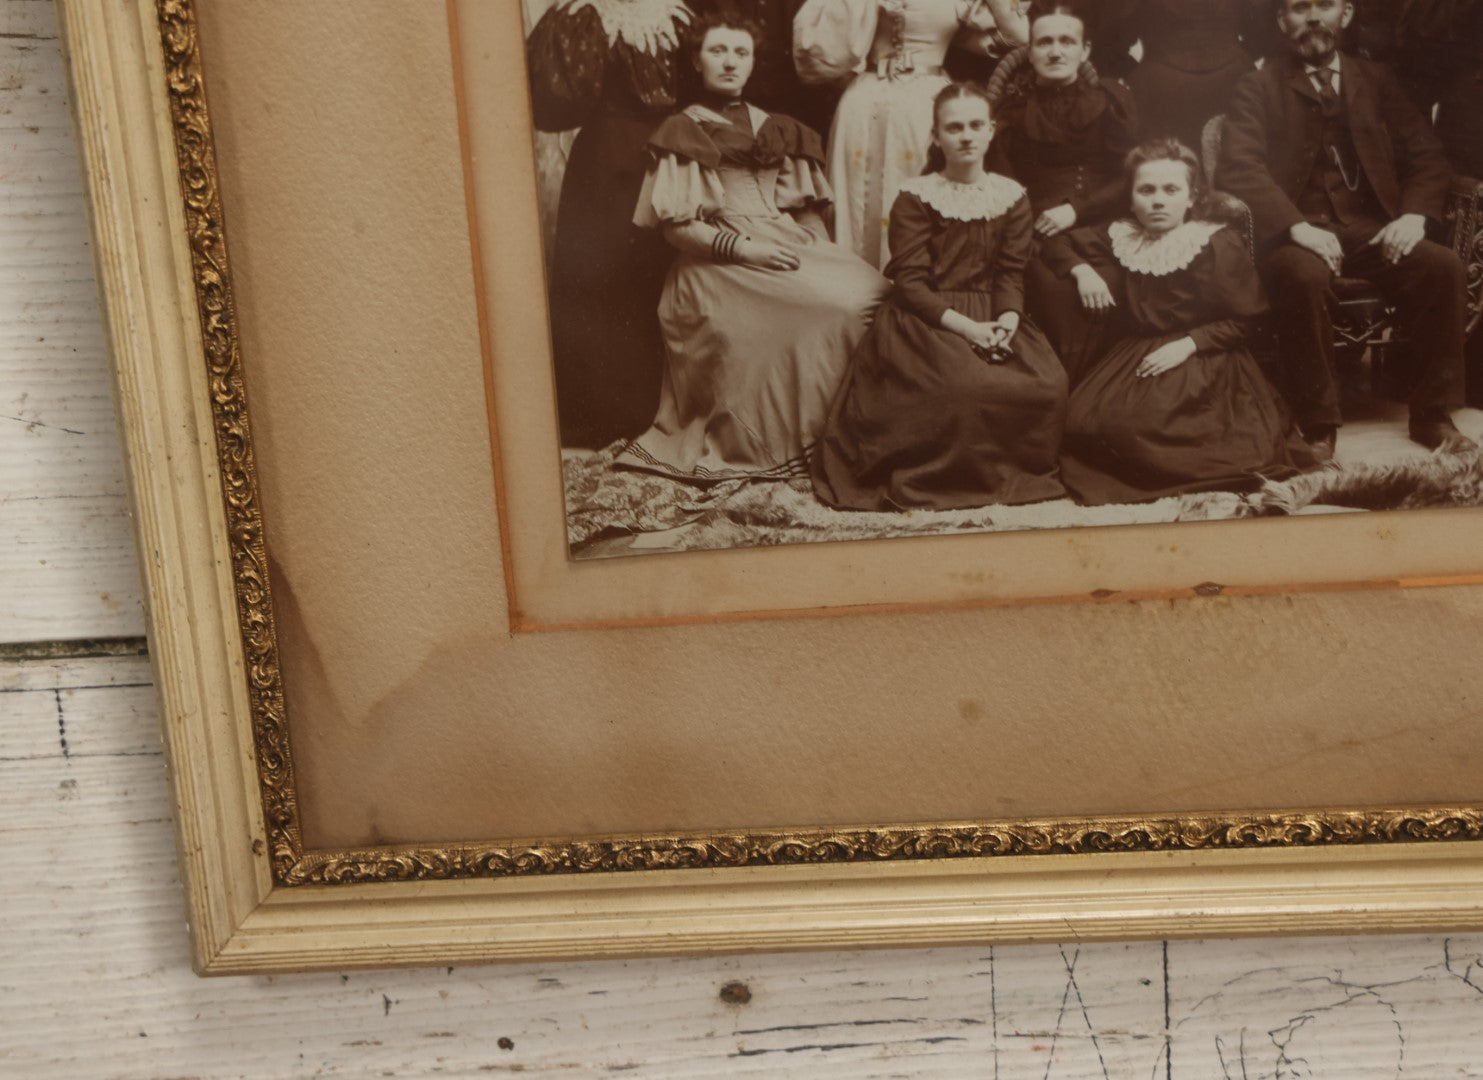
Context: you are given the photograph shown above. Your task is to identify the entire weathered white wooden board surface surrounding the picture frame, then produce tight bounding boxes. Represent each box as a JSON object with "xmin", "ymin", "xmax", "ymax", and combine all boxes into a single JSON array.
[{"xmin": 0, "ymin": 0, "xmax": 1483, "ymax": 1080}]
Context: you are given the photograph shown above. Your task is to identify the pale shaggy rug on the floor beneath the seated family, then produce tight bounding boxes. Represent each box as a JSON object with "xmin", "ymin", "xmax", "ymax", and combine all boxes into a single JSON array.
[{"xmin": 564, "ymin": 448, "xmax": 1483, "ymax": 558}]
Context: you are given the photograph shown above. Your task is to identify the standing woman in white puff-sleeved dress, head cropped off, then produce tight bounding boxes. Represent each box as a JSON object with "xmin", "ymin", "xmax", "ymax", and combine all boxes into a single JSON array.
[{"xmin": 793, "ymin": 0, "xmax": 1028, "ymax": 267}]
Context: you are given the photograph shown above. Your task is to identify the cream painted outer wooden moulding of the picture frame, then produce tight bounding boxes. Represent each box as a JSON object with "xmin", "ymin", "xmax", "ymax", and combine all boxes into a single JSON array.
[{"xmin": 59, "ymin": 0, "xmax": 1483, "ymax": 973}]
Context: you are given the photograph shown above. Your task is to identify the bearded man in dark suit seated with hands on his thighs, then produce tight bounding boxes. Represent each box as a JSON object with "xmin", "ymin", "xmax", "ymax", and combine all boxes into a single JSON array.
[{"xmin": 1216, "ymin": 0, "xmax": 1476, "ymax": 458}]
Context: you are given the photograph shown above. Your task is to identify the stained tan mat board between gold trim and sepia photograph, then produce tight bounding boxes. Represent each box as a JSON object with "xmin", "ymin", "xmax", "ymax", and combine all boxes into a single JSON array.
[{"xmin": 199, "ymin": 0, "xmax": 1483, "ymax": 849}]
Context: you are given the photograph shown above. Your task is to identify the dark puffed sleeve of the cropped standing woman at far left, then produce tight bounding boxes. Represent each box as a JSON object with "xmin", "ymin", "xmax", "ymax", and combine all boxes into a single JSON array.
[{"xmin": 525, "ymin": 4, "xmax": 610, "ymax": 131}]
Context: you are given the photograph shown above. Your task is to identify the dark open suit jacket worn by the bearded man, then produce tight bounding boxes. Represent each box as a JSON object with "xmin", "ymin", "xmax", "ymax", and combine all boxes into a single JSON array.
[{"xmin": 1216, "ymin": 53, "xmax": 1450, "ymax": 243}]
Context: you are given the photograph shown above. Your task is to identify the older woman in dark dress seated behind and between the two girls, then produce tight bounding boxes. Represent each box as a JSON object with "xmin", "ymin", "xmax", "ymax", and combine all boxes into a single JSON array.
[{"xmin": 988, "ymin": 3, "xmax": 1137, "ymax": 384}]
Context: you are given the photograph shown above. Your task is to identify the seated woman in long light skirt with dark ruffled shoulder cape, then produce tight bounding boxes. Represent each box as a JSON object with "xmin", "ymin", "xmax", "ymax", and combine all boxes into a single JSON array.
[{"xmin": 617, "ymin": 15, "xmax": 885, "ymax": 482}]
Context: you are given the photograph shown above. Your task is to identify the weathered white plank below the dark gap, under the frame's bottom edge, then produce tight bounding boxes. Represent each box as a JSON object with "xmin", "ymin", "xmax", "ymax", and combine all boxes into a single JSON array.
[{"xmin": 0, "ymin": 657, "xmax": 1483, "ymax": 1080}]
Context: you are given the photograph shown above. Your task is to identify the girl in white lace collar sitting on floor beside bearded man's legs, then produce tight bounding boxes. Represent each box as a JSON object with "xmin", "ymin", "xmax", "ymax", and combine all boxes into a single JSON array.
[{"xmin": 1046, "ymin": 139, "xmax": 1312, "ymax": 506}]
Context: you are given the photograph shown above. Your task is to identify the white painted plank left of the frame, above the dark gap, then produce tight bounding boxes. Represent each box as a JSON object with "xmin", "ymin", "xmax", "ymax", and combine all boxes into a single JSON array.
[{"xmin": 0, "ymin": 0, "xmax": 144, "ymax": 642}]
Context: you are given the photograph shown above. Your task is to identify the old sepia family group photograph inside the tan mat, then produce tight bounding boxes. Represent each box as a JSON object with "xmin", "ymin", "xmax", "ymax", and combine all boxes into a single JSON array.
[{"xmin": 523, "ymin": 0, "xmax": 1483, "ymax": 559}]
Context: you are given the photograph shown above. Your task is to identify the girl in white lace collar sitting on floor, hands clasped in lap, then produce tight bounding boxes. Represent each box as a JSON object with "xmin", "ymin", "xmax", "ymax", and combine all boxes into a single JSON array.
[{"xmin": 813, "ymin": 83, "xmax": 1066, "ymax": 510}]
